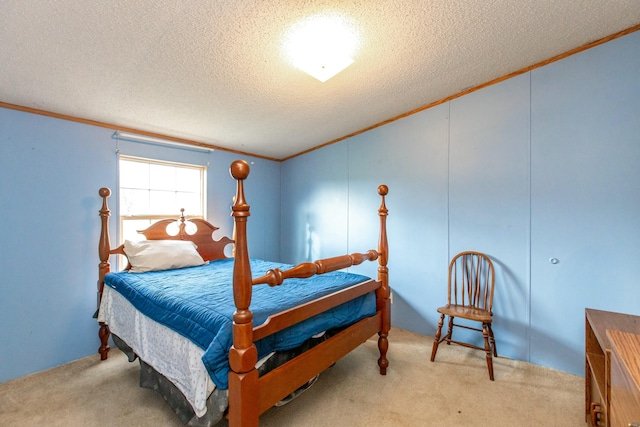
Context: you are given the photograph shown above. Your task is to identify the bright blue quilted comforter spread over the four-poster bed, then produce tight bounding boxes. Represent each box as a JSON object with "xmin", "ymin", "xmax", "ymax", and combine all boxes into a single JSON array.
[{"xmin": 104, "ymin": 258, "xmax": 376, "ymax": 389}]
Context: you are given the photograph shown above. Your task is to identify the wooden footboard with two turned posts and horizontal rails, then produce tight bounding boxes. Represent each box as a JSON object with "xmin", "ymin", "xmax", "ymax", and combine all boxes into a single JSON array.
[{"xmin": 229, "ymin": 160, "xmax": 391, "ymax": 427}]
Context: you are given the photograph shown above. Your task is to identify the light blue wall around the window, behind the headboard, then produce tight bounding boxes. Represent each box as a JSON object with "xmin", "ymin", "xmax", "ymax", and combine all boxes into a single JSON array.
[{"xmin": 0, "ymin": 108, "xmax": 280, "ymax": 382}]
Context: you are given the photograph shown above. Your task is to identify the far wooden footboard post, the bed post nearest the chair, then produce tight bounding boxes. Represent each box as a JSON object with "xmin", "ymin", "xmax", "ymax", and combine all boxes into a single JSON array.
[{"xmin": 376, "ymin": 185, "xmax": 391, "ymax": 375}]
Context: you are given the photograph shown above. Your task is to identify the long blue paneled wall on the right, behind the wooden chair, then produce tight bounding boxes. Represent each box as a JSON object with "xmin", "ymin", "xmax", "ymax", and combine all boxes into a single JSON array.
[{"xmin": 281, "ymin": 32, "xmax": 640, "ymax": 374}]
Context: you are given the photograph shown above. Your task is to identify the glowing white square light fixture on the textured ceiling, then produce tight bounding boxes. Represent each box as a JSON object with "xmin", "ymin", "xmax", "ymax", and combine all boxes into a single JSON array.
[{"xmin": 285, "ymin": 14, "xmax": 359, "ymax": 83}]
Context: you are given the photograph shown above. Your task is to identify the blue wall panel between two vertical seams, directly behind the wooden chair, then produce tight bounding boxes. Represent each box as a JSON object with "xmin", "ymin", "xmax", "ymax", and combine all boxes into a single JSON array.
[{"xmin": 443, "ymin": 74, "xmax": 530, "ymax": 360}]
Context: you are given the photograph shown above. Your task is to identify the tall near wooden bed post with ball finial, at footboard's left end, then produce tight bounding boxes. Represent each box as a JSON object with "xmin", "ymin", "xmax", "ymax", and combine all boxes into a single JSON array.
[{"xmin": 229, "ymin": 160, "xmax": 259, "ymax": 427}]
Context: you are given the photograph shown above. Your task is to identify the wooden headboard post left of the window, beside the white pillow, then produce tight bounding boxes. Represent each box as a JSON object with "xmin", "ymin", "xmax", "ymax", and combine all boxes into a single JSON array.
[{"xmin": 96, "ymin": 187, "xmax": 111, "ymax": 360}]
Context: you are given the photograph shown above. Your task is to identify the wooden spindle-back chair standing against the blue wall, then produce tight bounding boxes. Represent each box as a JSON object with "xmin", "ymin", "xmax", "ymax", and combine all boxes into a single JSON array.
[{"xmin": 431, "ymin": 251, "xmax": 498, "ymax": 381}]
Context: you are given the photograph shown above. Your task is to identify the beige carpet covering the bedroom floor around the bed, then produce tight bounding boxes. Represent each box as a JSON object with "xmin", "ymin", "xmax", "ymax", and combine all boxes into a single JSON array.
[{"xmin": 0, "ymin": 329, "xmax": 585, "ymax": 427}]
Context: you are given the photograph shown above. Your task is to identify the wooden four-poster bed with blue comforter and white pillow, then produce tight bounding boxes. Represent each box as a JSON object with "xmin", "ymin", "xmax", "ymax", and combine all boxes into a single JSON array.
[{"xmin": 96, "ymin": 160, "xmax": 391, "ymax": 427}]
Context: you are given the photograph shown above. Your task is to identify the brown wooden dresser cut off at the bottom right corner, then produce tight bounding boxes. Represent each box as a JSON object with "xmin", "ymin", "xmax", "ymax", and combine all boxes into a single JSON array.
[{"xmin": 585, "ymin": 309, "xmax": 640, "ymax": 427}]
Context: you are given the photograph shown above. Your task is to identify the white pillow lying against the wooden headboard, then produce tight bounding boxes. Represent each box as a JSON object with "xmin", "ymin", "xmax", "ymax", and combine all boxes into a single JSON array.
[{"xmin": 124, "ymin": 240, "xmax": 204, "ymax": 273}]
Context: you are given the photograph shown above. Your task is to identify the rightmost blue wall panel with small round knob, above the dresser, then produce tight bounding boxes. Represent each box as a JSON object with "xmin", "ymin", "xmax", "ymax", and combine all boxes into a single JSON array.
[{"xmin": 531, "ymin": 32, "xmax": 640, "ymax": 374}]
